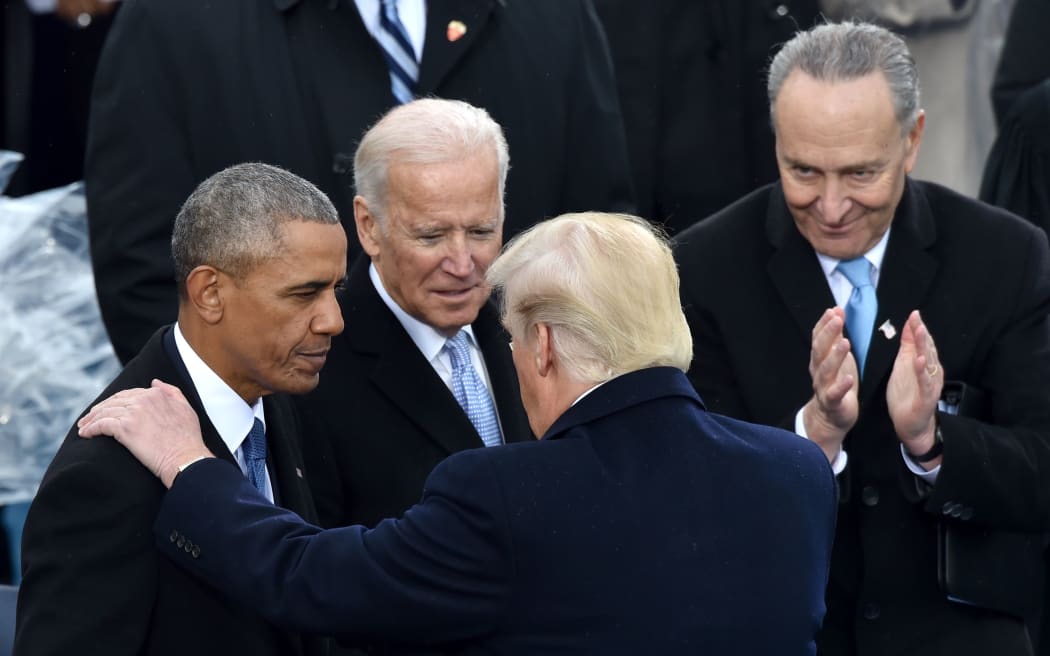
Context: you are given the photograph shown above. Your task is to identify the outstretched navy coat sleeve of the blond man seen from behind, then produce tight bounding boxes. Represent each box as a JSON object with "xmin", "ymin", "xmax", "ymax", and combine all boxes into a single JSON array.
[{"xmin": 154, "ymin": 451, "xmax": 512, "ymax": 644}]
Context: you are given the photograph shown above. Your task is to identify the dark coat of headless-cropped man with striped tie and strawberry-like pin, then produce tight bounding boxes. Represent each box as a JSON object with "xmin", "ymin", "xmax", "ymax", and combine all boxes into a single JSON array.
[{"xmin": 85, "ymin": 0, "xmax": 633, "ymax": 361}]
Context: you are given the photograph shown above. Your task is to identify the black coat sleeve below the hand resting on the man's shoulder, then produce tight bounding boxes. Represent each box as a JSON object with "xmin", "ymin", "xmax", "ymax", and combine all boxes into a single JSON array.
[{"xmin": 15, "ymin": 438, "xmax": 163, "ymax": 656}]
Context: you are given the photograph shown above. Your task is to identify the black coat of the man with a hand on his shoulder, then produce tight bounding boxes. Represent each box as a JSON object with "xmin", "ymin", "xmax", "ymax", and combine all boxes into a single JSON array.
[{"xmin": 15, "ymin": 329, "xmax": 323, "ymax": 656}]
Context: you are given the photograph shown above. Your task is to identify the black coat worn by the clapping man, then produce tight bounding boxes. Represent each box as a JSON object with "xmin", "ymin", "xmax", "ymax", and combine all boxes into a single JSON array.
[{"xmin": 676, "ymin": 179, "xmax": 1050, "ymax": 655}]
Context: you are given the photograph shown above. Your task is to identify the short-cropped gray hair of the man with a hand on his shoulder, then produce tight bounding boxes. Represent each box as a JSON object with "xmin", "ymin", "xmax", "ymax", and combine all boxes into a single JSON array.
[{"xmin": 171, "ymin": 163, "xmax": 339, "ymax": 294}]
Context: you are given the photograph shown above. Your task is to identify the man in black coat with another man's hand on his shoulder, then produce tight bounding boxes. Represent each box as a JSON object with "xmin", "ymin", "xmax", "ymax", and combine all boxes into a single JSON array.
[{"xmin": 15, "ymin": 164, "xmax": 347, "ymax": 656}]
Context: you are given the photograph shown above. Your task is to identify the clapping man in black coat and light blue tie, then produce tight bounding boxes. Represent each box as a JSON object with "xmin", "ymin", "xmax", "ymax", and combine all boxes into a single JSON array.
[{"xmin": 675, "ymin": 23, "xmax": 1050, "ymax": 656}]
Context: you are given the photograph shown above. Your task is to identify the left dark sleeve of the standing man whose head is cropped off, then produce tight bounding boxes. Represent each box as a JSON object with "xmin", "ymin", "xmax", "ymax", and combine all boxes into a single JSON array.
[{"xmin": 84, "ymin": 2, "xmax": 196, "ymax": 362}]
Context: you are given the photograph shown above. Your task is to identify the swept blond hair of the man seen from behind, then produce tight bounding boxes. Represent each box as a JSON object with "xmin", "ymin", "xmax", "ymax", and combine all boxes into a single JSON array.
[{"xmin": 486, "ymin": 212, "xmax": 693, "ymax": 383}]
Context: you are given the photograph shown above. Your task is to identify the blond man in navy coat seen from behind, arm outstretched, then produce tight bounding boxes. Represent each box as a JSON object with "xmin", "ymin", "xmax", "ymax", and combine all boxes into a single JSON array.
[{"xmin": 81, "ymin": 213, "xmax": 836, "ymax": 656}]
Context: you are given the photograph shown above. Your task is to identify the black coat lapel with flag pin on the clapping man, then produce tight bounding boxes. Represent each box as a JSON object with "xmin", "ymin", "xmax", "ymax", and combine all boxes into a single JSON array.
[{"xmin": 860, "ymin": 184, "xmax": 938, "ymax": 407}]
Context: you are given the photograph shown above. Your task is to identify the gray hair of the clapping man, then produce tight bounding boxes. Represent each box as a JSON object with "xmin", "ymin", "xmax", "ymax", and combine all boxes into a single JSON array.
[{"xmin": 767, "ymin": 21, "xmax": 920, "ymax": 134}]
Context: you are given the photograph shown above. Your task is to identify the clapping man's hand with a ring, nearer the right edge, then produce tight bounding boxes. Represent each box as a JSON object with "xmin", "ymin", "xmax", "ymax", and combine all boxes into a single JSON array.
[{"xmin": 886, "ymin": 310, "xmax": 944, "ymax": 457}]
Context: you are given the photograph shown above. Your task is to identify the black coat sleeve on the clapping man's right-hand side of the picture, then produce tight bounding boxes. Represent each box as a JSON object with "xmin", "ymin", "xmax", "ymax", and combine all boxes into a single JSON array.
[{"xmin": 926, "ymin": 224, "xmax": 1050, "ymax": 532}]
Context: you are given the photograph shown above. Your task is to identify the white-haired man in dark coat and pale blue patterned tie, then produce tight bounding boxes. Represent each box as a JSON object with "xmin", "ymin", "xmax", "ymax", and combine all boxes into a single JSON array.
[{"xmin": 296, "ymin": 99, "xmax": 534, "ymax": 527}]
